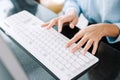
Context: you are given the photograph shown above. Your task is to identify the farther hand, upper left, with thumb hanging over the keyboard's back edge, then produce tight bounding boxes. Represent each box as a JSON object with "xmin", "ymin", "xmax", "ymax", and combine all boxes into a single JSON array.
[{"xmin": 41, "ymin": 10, "xmax": 78, "ymax": 32}]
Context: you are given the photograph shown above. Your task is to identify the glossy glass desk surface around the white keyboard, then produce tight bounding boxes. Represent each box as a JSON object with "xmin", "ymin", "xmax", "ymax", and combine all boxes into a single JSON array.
[{"xmin": 0, "ymin": 0, "xmax": 120, "ymax": 80}]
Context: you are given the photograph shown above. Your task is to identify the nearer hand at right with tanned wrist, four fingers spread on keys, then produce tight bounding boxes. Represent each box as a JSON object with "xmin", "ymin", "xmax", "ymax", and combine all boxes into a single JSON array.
[{"xmin": 66, "ymin": 23, "xmax": 118, "ymax": 54}]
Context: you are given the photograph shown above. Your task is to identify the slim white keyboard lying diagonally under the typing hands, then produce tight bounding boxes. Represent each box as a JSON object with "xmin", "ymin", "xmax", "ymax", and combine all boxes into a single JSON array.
[{"xmin": 0, "ymin": 11, "xmax": 98, "ymax": 80}]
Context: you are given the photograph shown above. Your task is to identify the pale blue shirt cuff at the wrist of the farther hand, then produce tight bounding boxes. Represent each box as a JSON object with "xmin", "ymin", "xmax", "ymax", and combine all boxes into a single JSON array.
[{"xmin": 63, "ymin": 1, "xmax": 81, "ymax": 16}]
